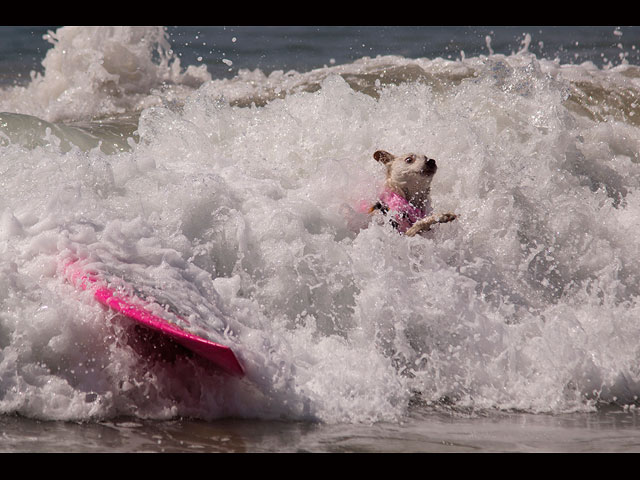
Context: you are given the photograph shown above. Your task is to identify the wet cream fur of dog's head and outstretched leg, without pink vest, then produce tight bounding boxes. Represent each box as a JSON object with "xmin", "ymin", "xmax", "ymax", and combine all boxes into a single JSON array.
[{"xmin": 373, "ymin": 150, "xmax": 457, "ymax": 237}]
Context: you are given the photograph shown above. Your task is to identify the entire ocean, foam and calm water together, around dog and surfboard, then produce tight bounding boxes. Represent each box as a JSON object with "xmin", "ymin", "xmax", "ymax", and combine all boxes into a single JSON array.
[{"xmin": 0, "ymin": 26, "xmax": 640, "ymax": 452}]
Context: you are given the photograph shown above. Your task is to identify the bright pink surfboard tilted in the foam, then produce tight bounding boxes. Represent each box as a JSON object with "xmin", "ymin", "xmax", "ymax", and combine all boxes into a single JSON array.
[{"xmin": 64, "ymin": 261, "xmax": 244, "ymax": 376}]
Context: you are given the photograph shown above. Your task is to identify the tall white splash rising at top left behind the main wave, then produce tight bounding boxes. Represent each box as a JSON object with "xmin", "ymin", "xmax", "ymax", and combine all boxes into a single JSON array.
[{"xmin": 0, "ymin": 26, "xmax": 211, "ymax": 121}]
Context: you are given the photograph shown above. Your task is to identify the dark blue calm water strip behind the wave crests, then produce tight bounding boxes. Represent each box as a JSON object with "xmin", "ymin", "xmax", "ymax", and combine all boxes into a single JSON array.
[{"xmin": 0, "ymin": 26, "xmax": 640, "ymax": 84}]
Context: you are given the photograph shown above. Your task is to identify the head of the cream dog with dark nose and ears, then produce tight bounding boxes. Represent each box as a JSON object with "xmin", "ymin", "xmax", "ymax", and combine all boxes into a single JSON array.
[{"xmin": 373, "ymin": 150, "xmax": 438, "ymax": 200}]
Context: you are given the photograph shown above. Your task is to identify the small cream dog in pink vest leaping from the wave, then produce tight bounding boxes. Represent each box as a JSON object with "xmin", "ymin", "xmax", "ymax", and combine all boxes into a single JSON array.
[{"xmin": 369, "ymin": 150, "xmax": 458, "ymax": 237}]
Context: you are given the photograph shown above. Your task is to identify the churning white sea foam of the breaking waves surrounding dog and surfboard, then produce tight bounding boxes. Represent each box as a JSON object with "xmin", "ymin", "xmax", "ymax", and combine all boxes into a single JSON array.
[{"xmin": 0, "ymin": 29, "xmax": 640, "ymax": 422}]
